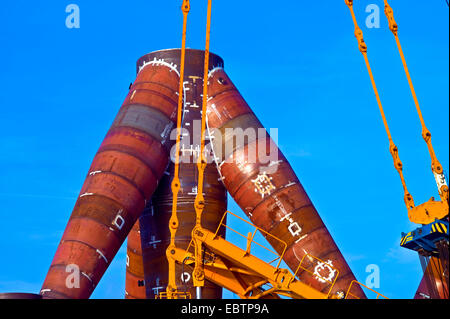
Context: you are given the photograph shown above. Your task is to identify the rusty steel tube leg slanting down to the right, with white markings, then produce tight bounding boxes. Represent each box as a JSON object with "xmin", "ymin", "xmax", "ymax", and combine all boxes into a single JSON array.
[{"xmin": 207, "ymin": 68, "xmax": 365, "ymax": 298}]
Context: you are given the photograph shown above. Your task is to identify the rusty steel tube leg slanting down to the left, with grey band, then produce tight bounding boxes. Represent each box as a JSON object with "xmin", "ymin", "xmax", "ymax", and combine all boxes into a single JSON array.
[{"xmin": 41, "ymin": 61, "xmax": 179, "ymax": 298}]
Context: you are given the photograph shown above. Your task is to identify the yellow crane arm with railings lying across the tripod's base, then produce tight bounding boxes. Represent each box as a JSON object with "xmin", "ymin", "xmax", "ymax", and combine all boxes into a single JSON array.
[{"xmin": 169, "ymin": 212, "xmax": 386, "ymax": 299}]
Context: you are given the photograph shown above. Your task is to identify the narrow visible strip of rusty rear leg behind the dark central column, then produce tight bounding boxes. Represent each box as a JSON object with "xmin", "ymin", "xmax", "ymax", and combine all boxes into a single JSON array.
[{"xmin": 125, "ymin": 220, "xmax": 146, "ymax": 299}]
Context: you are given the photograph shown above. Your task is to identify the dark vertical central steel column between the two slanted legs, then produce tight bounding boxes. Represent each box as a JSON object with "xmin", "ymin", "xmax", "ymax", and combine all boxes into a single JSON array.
[{"xmin": 141, "ymin": 49, "xmax": 227, "ymax": 299}]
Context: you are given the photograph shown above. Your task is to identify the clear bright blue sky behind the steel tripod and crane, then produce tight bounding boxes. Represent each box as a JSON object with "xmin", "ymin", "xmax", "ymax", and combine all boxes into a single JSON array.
[{"xmin": 0, "ymin": 0, "xmax": 449, "ymax": 298}]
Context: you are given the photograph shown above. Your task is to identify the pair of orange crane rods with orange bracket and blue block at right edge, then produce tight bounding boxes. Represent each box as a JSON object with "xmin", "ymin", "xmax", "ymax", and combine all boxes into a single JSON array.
[{"xmin": 345, "ymin": 0, "xmax": 449, "ymax": 298}]
